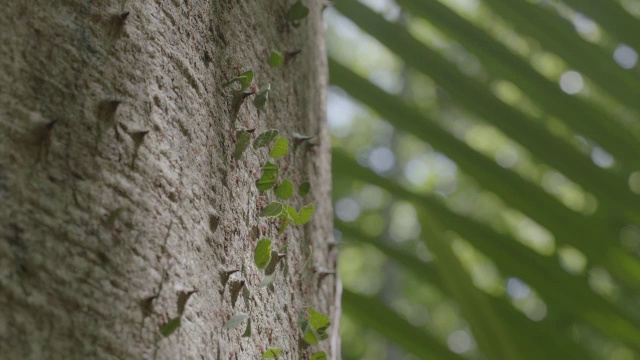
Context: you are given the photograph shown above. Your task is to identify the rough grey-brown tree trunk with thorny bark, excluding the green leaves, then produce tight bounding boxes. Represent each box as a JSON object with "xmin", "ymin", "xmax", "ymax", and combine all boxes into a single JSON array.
[{"xmin": 0, "ymin": 0, "xmax": 339, "ymax": 359}]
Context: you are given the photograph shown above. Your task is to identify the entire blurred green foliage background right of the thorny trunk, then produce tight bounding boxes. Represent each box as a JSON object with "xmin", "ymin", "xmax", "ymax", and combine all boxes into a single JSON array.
[{"xmin": 325, "ymin": 0, "xmax": 640, "ymax": 360}]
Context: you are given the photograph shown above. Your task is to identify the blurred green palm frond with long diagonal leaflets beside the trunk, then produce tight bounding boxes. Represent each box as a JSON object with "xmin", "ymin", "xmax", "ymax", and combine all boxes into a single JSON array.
[{"xmin": 329, "ymin": 0, "xmax": 640, "ymax": 360}]
